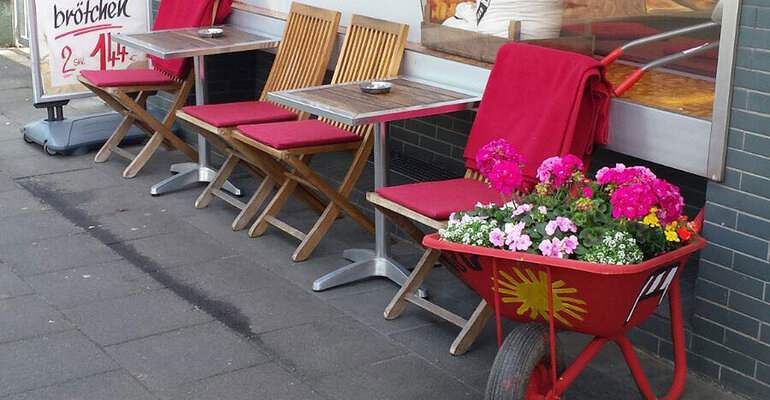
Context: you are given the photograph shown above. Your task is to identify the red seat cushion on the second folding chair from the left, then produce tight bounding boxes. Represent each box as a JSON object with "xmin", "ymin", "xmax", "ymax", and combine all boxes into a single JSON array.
[{"xmin": 182, "ymin": 101, "xmax": 297, "ymax": 128}]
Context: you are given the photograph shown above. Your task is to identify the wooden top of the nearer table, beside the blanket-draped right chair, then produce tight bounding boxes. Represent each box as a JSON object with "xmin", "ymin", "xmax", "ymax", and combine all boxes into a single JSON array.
[{"xmin": 268, "ymin": 77, "xmax": 481, "ymax": 126}]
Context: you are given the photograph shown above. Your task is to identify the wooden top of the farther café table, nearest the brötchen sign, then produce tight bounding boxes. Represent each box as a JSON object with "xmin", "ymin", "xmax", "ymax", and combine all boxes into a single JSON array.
[{"xmin": 112, "ymin": 25, "xmax": 280, "ymax": 59}]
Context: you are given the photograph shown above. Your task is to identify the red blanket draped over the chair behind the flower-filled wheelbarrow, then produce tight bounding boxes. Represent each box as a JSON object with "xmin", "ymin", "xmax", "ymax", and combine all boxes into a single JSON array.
[{"xmin": 463, "ymin": 43, "xmax": 611, "ymax": 182}]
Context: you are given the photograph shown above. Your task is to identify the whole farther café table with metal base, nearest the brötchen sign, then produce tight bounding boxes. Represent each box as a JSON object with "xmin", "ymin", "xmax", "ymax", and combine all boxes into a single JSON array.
[{"xmin": 112, "ymin": 25, "xmax": 279, "ymax": 196}]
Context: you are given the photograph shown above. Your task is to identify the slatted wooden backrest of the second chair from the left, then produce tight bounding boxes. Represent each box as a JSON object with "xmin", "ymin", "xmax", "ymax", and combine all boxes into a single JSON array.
[{"xmin": 259, "ymin": 2, "xmax": 340, "ymax": 118}]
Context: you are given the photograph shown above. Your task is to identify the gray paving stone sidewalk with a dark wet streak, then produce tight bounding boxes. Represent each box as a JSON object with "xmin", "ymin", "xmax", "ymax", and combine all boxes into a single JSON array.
[{"xmin": 0, "ymin": 50, "xmax": 748, "ymax": 400}]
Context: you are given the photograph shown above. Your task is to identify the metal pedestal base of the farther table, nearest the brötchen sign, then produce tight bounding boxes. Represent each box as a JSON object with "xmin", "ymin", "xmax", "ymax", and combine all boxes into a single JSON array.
[{"xmin": 150, "ymin": 56, "xmax": 241, "ymax": 196}]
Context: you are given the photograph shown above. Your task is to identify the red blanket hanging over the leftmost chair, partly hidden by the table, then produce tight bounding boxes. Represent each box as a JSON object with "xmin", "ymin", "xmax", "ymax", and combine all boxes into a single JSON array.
[{"xmin": 147, "ymin": 0, "xmax": 233, "ymax": 79}]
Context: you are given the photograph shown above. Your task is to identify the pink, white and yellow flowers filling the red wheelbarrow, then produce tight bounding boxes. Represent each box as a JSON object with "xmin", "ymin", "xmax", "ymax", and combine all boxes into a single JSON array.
[{"xmin": 439, "ymin": 139, "xmax": 696, "ymax": 264}]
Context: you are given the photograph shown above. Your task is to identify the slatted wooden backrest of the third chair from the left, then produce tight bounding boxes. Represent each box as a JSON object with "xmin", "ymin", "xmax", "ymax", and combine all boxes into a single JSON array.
[{"xmin": 321, "ymin": 15, "xmax": 409, "ymax": 136}]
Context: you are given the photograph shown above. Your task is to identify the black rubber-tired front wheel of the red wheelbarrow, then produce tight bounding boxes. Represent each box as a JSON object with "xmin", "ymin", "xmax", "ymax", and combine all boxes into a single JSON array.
[{"xmin": 484, "ymin": 324, "xmax": 565, "ymax": 400}]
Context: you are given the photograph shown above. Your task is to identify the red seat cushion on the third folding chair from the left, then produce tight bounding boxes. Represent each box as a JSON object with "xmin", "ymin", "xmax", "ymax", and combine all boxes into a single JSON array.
[{"xmin": 238, "ymin": 119, "xmax": 361, "ymax": 150}]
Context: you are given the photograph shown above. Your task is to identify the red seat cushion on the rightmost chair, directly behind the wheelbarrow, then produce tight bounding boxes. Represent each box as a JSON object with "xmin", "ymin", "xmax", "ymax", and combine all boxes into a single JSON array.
[{"xmin": 377, "ymin": 178, "xmax": 502, "ymax": 220}]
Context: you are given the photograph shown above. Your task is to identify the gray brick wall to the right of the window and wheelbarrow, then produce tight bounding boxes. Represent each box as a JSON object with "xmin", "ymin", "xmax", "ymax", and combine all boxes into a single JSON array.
[{"xmin": 690, "ymin": 0, "xmax": 770, "ymax": 398}]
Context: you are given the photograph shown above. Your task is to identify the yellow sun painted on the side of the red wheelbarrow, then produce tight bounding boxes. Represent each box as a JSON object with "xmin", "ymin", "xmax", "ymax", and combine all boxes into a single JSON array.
[{"xmin": 492, "ymin": 267, "xmax": 588, "ymax": 326}]
